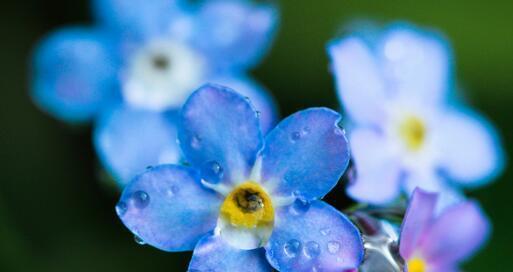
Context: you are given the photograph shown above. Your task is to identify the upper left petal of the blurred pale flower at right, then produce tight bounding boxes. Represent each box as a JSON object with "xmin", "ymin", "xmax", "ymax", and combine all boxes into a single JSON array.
[{"xmin": 328, "ymin": 37, "xmax": 386, "ymax": 124}]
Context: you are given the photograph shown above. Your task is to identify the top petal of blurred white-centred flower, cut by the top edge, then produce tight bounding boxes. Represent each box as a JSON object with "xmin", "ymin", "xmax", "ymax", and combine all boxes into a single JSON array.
[{"xmin": 93, "ymin": 0, "xmax": 184, "ymax": 38}]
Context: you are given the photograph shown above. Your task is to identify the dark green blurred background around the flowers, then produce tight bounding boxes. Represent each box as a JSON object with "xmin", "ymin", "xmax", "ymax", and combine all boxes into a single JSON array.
[{"xmin": 0, "ymin": 0, "xmax": 513, "ymax": 272}]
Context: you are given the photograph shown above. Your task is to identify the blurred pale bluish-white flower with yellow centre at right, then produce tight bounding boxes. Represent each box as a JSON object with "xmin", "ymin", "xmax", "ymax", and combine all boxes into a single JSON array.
[{"xmin": 329, "ymin": 24, "xmax": 503, "ymax": 206}]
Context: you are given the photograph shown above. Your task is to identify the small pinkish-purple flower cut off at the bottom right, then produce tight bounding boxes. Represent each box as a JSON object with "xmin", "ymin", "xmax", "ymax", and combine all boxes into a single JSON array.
[{"xmin": 399, "ymin": 189, "xmax": 490, "ymax": 272}]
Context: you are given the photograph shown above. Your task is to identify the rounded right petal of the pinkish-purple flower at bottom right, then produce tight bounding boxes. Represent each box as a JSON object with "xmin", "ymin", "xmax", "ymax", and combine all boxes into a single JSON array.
[{"xmin": 420, "ymin": 201, "xmax": 490, "ymax": 265}]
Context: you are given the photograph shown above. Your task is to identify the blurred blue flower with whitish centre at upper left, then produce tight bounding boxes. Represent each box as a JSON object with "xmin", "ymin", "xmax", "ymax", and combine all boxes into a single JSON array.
[{"xmin": 32, "ymin": 0, "xmax": 278, "ymax": 185}]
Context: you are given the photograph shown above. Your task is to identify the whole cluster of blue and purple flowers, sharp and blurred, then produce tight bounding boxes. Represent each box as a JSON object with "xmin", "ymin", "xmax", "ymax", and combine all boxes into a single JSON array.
[{"xmin": 32, "ymin": 0, "xmax": 503, "ymax": 272}]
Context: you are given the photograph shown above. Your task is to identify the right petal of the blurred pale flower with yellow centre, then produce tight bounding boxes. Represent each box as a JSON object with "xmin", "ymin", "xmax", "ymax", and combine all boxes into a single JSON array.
[{"xmin": 434, "ymin": 108, "xmax": 503, "ymax": 185}]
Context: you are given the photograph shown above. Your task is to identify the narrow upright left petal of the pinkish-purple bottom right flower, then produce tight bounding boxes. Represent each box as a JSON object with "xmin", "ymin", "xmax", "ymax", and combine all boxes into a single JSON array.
[{"xmin": 399, "ymin": 188, "xmax": 438, "ymax": 260}]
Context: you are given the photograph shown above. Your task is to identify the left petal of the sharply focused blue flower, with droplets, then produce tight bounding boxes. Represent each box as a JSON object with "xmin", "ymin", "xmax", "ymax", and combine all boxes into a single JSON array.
[{"xmin": 116, "ymin": 165, "xmax": 221, "ymax": 251}]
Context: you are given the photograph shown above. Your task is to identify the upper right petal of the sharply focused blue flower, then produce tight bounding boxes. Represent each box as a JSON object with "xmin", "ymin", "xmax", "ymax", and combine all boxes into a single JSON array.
[{"xmin": 260, "ymin": 108, "xmax": 349, "ymax": 200}]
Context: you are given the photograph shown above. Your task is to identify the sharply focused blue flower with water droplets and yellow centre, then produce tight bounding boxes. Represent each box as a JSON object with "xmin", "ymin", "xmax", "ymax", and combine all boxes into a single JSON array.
[{"xmin": 116, "ymin": 85, "xmax": 363, "ymax": 271}]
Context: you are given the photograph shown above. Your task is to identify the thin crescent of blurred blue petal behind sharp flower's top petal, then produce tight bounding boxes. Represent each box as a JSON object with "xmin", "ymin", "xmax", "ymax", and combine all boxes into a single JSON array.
[{"xmin": 209, "ymin": 75, "xmax": 278, "ymax": 134}]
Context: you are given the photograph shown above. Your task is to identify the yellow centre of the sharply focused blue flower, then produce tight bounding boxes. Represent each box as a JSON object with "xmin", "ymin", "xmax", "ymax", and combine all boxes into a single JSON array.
[{"xmin": 221, "ymin": 181, "xmax": 274, "ymax": 228}]
